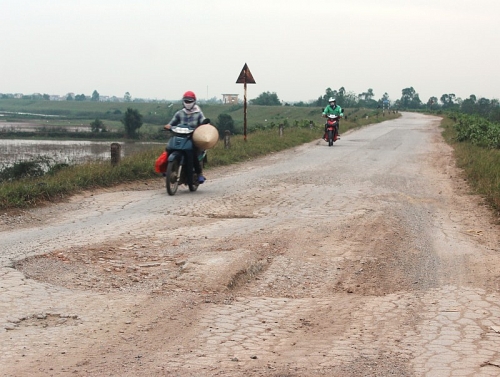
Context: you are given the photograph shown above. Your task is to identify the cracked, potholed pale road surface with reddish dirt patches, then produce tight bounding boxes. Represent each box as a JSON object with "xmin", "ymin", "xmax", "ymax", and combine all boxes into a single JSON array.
[{"xmin": 0, "ymin": 113, "xmax": 500, "ymax": 377}]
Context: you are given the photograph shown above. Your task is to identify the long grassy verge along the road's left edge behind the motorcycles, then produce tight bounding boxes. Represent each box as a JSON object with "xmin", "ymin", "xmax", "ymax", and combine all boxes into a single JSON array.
[{"xmin": 0, "ymin": 108, "xmax": 399, "ymax": 209}]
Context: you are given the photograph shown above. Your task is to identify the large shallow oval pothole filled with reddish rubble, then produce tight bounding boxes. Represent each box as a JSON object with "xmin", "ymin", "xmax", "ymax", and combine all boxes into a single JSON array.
[{"xmin": 14, "ymin": 247, "xmax": 179, "ymax": 292}]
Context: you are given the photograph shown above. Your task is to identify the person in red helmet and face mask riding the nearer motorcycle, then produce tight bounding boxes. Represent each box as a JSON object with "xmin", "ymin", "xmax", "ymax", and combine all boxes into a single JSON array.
[{"xmin": 163, "ymin": 90, "xmax": 207, "ymax": 183}]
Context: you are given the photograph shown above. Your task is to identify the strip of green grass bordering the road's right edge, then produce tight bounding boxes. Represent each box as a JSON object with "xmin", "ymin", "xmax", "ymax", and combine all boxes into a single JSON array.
[{"xmin": 441, "ymin": 118, "xmax": 500, "ymax": 217}]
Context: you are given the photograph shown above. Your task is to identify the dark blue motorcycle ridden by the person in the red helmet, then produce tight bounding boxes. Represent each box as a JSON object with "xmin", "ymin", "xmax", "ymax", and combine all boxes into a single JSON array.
[{"xmin": 165, "ymin": 124, "xmax": 207, "ymax": 195}]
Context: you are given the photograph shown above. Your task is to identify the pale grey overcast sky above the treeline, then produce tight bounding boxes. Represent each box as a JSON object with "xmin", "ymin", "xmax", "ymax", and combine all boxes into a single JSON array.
[{"xmin": 0, "ymin": 0, "xmax": 500, "ymax": 102}]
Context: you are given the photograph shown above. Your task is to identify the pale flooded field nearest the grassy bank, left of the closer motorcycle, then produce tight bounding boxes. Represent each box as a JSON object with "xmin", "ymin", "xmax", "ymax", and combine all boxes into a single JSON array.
[{"xmin": 0, "ymin": 139, "xmax": 165, "ymax": 169}]
